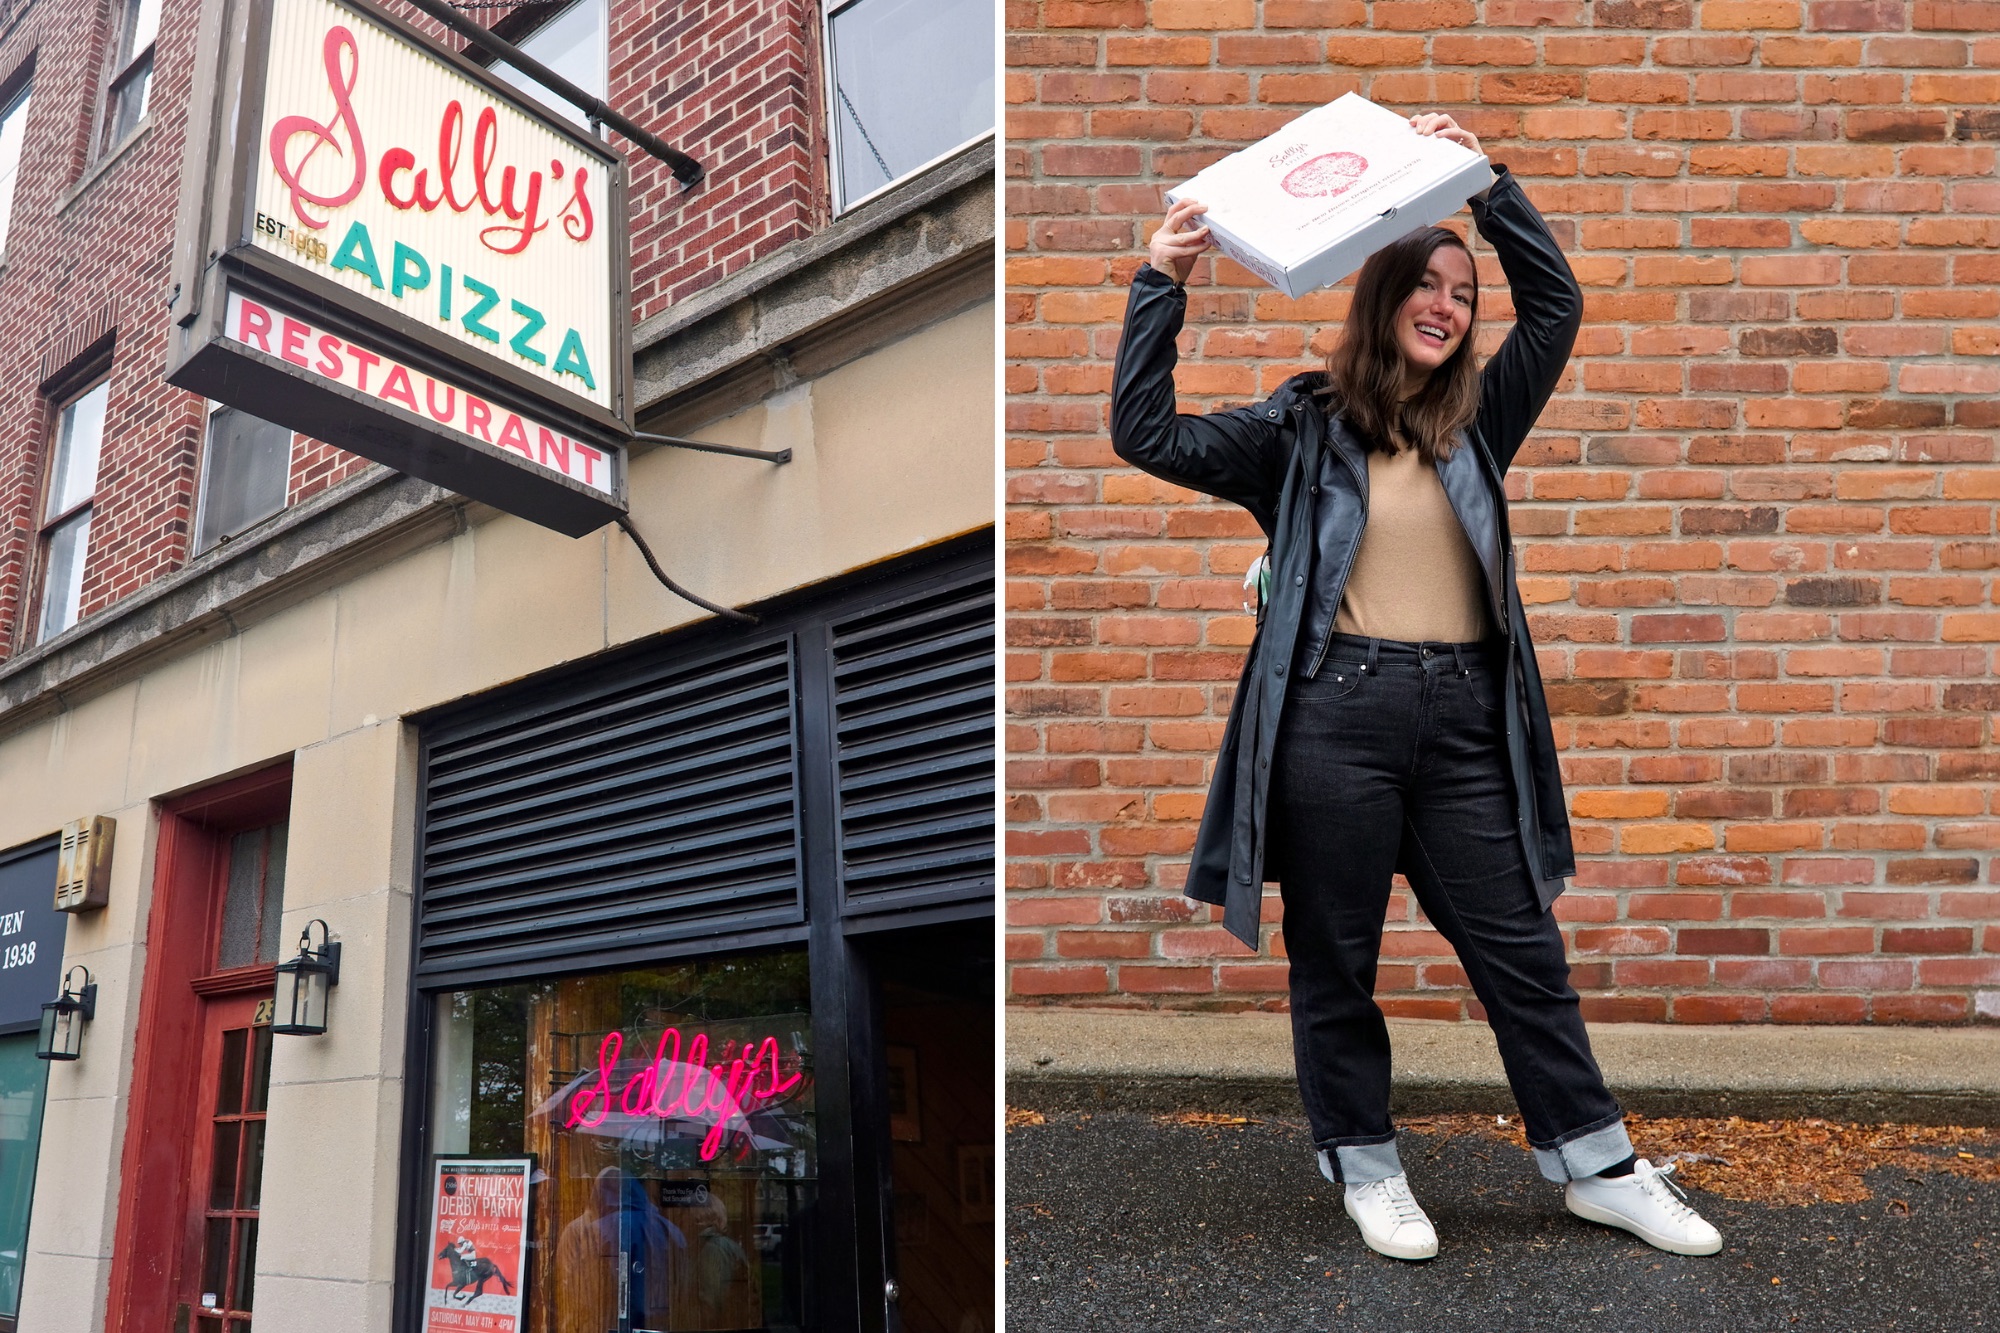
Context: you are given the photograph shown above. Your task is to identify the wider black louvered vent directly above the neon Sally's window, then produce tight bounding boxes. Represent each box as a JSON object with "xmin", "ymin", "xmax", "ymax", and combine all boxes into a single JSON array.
[{"xmin": 418, "ymin": 636, "xmax": 804, "ymax": 981}]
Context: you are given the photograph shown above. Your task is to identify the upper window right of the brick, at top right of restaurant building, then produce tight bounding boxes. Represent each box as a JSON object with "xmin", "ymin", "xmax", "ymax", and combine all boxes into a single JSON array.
[{"xmin": 826, "ymin": 0, "xmax": 994, "ymax": 210}]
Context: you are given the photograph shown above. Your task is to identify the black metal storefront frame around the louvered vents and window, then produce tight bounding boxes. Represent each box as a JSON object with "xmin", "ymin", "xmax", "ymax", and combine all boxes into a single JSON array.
[{"xmin": 396, "ymin": 530, "xmax": 998, "ymax": 1333}]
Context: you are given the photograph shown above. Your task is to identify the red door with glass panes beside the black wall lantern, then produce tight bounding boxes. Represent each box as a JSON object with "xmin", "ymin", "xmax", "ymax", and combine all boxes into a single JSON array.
[{"xmin": 174, "ymin": 989, "xmax": 270, "ymax": 1333}]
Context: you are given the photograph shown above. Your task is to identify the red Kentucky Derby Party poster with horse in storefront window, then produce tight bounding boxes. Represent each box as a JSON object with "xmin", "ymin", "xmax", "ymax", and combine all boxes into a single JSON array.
[{"xmin": 424, "ymin": 1157, "xmax": 534, "ymax": 1333}]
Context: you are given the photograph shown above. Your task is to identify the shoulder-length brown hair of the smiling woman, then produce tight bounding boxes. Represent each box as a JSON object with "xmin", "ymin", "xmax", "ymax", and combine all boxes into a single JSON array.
[{"xmin": 1322, "ymin": 226, "xmax": 1480, "ymax": 462}]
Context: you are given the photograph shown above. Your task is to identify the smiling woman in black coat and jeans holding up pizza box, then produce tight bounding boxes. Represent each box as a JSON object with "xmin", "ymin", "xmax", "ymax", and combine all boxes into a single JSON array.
[{"xmin": 1112, "ymin": 114, "xmax": 1722, "ymax": 1259}]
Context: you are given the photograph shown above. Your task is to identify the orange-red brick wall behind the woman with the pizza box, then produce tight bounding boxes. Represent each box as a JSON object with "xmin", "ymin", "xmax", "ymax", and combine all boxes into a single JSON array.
[{"xmin": 1006, "ymin": 0, "xmax": 2000, "ymax": 1023}]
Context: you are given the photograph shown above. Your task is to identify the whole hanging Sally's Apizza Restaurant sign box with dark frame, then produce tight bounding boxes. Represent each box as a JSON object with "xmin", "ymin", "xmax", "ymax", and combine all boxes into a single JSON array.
[{"xmin": 166, "ymin": 0, "xmax": 632, "ymax": 534}]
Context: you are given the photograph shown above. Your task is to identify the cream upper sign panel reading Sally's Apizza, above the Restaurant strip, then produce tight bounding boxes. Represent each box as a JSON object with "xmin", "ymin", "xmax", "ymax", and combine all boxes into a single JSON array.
[{"xmin": 250, "ymin": 0, "xmax": 614, "ymax": 406}]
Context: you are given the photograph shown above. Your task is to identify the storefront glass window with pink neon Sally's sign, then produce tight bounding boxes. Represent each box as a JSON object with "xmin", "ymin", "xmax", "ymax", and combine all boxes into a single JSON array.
[{"xmin": 424, "ymin": 949, "xmax": 818, "ymax": 1333}]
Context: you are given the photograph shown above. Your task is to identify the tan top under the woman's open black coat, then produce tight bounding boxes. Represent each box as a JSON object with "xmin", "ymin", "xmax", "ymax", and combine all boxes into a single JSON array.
[{"xmin": 1334, "ymin": 448, "xmax": 1486, "ymax": 642}]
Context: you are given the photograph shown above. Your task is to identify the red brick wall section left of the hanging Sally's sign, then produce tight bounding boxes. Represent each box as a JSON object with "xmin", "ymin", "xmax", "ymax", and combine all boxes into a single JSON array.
[{"xmin": 0, "ymin": 0, "xmax": 200, "ymax": 654}]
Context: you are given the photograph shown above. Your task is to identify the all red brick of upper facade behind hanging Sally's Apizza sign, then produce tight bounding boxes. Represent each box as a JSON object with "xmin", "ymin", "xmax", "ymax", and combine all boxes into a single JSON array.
[{"xmin": 0, "ymin": 0, "xmax": 828, "ymax": 658}]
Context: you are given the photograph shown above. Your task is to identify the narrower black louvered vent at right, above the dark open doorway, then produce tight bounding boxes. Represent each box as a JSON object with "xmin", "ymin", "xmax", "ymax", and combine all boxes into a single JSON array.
[{"xmin": 832, "ymin": 578, "xmax": 994, "ymax": 913}]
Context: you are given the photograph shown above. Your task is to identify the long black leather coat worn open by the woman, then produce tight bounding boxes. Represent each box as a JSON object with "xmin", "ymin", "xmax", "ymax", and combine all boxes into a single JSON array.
[{"xmin": 1112, "ymin": 168, "xmax": 1584, "ymax": 949}]
